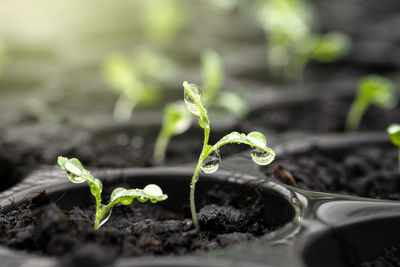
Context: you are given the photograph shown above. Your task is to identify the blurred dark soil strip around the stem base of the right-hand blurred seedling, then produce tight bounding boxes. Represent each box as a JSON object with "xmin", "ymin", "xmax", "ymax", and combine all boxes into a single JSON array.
[{"xmin": 241, "ymin": 95, "xmax": 400, "ymax": 134}]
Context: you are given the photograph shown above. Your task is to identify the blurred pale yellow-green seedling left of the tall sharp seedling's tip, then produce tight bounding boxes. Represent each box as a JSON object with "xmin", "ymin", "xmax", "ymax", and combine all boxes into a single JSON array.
[{"xmin": 102, "ymin": 48, "xmax": 176, "ymax": 122}]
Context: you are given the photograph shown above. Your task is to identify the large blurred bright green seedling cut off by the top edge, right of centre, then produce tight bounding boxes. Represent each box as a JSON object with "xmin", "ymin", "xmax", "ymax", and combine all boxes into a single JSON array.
[{"xmin": 253, "ymin": 0, "xmax": 351, "ymax": 80}]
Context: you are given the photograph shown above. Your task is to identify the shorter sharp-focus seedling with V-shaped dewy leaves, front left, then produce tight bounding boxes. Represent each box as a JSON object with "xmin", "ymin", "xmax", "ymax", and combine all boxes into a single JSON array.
[{"xmin": 57, "ymin": 157, "xmax": 168, "ymax": 230}]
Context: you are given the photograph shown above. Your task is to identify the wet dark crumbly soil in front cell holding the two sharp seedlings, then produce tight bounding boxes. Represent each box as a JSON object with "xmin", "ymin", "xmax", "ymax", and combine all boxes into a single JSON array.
[{"xmin": 0, "ymin": 185, "xmax": 274, "ymax": 266}]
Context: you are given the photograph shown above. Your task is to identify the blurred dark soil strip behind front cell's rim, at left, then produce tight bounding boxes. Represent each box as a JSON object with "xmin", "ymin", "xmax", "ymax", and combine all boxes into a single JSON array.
[{"xmin": 0, "ymin": 124, "xmax": 243, "ymax": 191}]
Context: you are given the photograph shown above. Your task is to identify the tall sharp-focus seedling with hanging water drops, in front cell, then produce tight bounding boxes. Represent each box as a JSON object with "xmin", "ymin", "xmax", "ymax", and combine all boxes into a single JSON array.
[{"xmin": 183, "ymin": 82, "xmax": 276, "ymax": 230}]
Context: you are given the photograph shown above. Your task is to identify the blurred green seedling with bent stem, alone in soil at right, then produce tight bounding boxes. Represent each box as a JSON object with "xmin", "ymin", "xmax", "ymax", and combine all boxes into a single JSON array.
[{"xmin": 346, "ymin": 75, "xmax": 397, "ymax": 131}]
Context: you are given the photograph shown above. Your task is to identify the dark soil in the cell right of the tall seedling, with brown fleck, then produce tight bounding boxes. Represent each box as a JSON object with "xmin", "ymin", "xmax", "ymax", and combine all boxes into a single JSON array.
[{"xmin": 263, "ymin": 144, "xmax": 400, "ymax": 200}]
